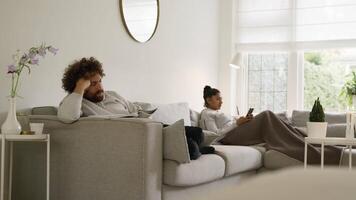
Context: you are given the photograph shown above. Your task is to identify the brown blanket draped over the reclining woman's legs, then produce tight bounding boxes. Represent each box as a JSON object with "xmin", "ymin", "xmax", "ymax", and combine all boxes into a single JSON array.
[{"xmin": 220, "ymin": 111, "xmax": 341, "ymax": 164}]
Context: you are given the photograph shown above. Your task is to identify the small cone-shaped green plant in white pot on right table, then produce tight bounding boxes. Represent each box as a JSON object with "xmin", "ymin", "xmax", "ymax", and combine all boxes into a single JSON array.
[{"xmin": 307, "ymin": 97, "xmax": 328, "ymax": 138}]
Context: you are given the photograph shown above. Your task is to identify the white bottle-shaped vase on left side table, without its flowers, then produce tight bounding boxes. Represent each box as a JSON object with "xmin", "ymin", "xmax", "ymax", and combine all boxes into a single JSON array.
[{"xmin": 1, "ymin": 97, "xmax": 21, "ymax": 134}]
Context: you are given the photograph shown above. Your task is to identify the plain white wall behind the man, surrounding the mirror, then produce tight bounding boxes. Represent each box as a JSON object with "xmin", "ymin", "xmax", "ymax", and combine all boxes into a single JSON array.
[{"xmin": 0, "ymin": 0, "xmax": 221, "ymax": 122}]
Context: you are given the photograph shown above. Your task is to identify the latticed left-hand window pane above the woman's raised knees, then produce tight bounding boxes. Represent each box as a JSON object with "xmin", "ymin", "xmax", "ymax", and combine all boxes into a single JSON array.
[{"xmin": 248, "ymin": 53, "xmax": 288, "ymax": 113}]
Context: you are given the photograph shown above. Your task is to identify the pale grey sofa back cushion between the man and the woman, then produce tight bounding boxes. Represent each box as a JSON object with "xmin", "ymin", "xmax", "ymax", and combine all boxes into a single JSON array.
[{"xmin": 151, "ymin": 103, "xmax": 191, "ymax": 126}]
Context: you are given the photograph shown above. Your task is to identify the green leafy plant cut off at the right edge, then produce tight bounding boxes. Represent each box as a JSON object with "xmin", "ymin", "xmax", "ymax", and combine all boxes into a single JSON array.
[{"xmin": 340, "ymin": 71, "xmax": 356, "ymax": 110}]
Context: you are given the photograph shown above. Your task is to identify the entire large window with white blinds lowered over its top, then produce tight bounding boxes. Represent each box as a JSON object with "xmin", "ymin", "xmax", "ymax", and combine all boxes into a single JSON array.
[{"xmin": 233, "ymin": 0, "xmax": 356, "ymax": 112}]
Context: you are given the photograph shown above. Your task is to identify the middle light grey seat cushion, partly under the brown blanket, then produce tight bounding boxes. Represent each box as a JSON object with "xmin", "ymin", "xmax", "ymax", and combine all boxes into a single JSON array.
[{"xmin": 214, "ymin": 145, "xmax": 262, "ymax": 176}]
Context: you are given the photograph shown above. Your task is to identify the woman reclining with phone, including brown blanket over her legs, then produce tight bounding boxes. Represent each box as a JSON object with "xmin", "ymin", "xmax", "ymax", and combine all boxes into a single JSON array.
[{"xmin": 200, "ymin": 86, "xmax": 341, "ymax": 165}]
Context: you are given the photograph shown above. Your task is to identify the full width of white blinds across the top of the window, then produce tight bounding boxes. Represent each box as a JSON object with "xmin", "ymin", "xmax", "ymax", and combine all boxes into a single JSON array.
[{"xmin": 235, "ymin": 0, "xmax": 356, "ymax": 44}]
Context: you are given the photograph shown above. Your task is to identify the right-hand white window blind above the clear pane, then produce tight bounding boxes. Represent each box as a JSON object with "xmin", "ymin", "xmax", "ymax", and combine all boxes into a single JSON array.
[{"xmin": 296, "ymin": 0, "xmax": 356, "ymax": 41}]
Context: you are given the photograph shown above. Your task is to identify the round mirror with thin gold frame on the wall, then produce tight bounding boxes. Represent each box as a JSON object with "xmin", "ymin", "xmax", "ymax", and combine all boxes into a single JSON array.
[{"xmin": 120, "ymin": 0, "xmax": 159, "ymax": 43}]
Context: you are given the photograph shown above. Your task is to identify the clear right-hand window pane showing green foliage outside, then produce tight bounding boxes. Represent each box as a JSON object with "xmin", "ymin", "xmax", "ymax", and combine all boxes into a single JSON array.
[{"xmin": 304, "ymin": 49, "xmax": 356, "ymax": 111}]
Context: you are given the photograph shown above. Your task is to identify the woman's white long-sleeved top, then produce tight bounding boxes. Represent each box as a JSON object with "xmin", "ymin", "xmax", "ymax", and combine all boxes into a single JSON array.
[{"xmin": 199, "ymin": 108, "xmax": 237, "ymax": 135}]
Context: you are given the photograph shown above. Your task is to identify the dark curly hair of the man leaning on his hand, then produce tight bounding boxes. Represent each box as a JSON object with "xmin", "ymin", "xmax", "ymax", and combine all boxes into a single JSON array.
[{"xmin": 62, "ymin": 57, "xmax": 105, "ymax": 93}]
